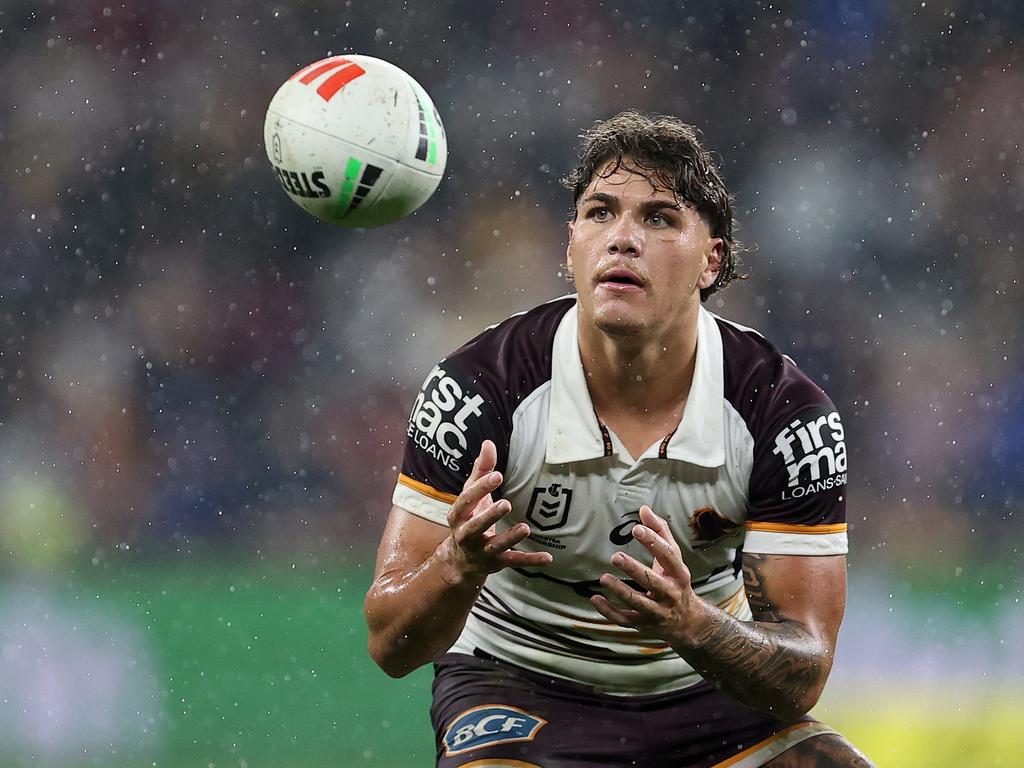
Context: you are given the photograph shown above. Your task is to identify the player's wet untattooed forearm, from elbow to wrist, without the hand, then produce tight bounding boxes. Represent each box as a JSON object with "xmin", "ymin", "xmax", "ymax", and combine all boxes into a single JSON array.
[{"xmin": 365, "ymin": 538, "xmax": 483, "ymax": 677}]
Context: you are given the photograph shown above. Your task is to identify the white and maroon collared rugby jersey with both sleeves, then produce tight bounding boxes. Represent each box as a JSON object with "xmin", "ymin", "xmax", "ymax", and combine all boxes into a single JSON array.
[{"xmin": 393, "ymin": 297, "xmax": 847, "ymax": 694}]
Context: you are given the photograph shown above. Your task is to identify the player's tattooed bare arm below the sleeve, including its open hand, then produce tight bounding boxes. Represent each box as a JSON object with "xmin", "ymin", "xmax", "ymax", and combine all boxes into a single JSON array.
[{"xmin": 592, "ymin": 507, "xmax": 846, "ymax": 720}]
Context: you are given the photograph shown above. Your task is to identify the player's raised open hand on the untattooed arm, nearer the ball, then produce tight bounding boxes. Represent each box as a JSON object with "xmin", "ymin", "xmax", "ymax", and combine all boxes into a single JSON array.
[{"xmin": 441, "ymin": 440, "xmax": 552, "ymax": 585}]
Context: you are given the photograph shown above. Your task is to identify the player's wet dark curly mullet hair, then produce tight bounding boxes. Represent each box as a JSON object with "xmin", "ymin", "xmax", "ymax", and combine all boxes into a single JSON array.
[{"xmin": 562, "ymin": 110, "xmax": 746, "ymax": 301}]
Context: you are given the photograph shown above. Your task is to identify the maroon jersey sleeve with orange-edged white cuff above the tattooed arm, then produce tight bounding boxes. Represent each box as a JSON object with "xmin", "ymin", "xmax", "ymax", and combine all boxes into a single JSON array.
[{"xmin": 743, "ymin": 370, "xmax": 848, "ymax": 555}]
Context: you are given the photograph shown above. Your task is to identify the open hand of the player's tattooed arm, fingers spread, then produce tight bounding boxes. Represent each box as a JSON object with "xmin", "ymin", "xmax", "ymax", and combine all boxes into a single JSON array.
[{"xmin": 591, "ymin": 506, "xmax": 700, "ymax": 646}]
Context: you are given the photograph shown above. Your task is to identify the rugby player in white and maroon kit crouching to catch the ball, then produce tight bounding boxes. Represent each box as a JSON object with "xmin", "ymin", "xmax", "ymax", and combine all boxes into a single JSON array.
[{"xmin": 366, "ymin": 112, "xmax": 870, "ymax": 768}]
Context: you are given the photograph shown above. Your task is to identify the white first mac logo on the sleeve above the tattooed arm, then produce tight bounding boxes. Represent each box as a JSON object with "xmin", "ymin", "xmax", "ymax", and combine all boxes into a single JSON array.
[{"xmin": 772, "ymin": 411, "xmax": 846, "ymax": 499}]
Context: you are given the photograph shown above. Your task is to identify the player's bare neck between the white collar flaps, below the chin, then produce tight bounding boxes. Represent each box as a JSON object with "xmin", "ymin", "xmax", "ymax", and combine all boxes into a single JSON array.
[{"xmin": 579, "ymin": 312, "xmax": 697, "ymax": 432}]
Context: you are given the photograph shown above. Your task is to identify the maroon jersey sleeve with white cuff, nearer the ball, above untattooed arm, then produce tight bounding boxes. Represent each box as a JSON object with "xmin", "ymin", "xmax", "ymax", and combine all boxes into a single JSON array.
[{"xmin": 391, "ymin": 360, "xmax": 508, "ymax": 525}]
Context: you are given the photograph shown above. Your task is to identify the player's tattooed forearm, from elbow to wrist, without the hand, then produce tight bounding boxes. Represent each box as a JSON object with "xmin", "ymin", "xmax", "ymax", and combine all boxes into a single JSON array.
[{"xmin": 673, "ymin": 603, "xmax": 831, "ymax": 720}]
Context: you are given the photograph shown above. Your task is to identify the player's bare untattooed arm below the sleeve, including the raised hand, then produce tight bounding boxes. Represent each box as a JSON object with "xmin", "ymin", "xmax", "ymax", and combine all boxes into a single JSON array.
[{"xmin": 364, "ymin": 440, "xmax": 551, "ymax": 677}]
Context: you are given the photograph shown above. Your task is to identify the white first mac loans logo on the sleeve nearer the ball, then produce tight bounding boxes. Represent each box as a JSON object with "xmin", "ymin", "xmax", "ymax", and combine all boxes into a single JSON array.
[{"xmin": 407, "ymin": 366, "xmax": 483, "ymax": 472}]
